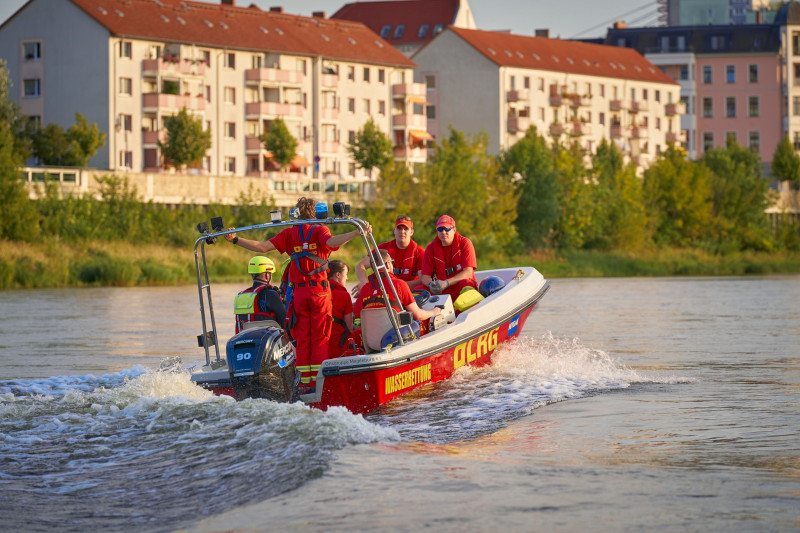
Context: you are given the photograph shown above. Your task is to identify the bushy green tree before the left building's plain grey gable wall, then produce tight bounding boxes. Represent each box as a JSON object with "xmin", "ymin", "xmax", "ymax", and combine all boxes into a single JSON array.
[{"xmin": 31, "ymin": 113, "xmax": 106, "ymax": 167}]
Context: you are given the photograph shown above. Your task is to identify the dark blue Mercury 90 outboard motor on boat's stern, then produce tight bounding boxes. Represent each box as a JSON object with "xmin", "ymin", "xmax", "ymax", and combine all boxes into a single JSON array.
[{"xmin": 226, "ymin": 326, "xmax": 300, "ymax": 402}]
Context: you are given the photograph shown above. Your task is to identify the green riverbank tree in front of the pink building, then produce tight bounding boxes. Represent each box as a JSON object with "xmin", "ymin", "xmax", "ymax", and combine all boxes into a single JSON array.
[{"xmin": 702, "ymin": 138, "xmax": 777, "ymax": 249}]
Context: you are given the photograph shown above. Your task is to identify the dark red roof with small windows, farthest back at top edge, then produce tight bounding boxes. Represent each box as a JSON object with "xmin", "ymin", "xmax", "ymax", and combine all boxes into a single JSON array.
[{"xmin": 331, "ymin": 0, "xmax": 460, "ymax": 45}]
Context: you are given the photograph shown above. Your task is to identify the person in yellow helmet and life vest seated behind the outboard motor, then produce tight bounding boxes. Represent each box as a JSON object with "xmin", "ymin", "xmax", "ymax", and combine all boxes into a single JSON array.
[{"xmin": 233, "ymin": 255, "xmax": 286, "ymax": 333}]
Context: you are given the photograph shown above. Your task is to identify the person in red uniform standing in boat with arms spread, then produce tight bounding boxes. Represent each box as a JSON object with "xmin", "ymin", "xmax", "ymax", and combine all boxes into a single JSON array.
[{"xmin": 225, "ymin": 197, "xmax": 372, "ymax": 394}]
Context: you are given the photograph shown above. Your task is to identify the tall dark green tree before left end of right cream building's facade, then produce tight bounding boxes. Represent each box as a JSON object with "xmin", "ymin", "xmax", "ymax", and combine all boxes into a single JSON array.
[{"xmin": 498, "ymin": 127, "xmax": 561, "ymax": 249}]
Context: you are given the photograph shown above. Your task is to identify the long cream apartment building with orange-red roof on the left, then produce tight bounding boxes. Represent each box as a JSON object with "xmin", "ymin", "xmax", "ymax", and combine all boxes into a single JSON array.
[{"xmin": 0, "ymin": 0, "xmax": 427, "ymax": 185}]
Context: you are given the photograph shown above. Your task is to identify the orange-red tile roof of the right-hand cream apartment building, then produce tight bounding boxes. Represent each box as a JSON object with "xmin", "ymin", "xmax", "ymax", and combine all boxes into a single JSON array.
[{"xmin": 440, "ymin": 26, "xmax": 678, "ymax": 85}]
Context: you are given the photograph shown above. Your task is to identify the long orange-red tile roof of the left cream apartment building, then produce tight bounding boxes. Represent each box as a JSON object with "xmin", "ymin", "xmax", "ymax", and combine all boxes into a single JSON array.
[{"xmin": 71, "ymin": 0, "xmax": 416, "ymax": 68}]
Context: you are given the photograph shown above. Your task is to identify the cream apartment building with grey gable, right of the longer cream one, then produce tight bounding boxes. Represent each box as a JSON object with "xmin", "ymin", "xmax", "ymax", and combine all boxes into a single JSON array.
[{"xmin": 412, "ymin": 26, "xmax": 682, "ymax": 166}]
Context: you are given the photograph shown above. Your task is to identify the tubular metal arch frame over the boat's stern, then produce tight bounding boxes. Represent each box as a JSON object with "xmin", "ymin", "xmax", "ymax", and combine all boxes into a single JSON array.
[{"xmin": 194, "ymin": 213, "xmax": 407, "ymax": 367}]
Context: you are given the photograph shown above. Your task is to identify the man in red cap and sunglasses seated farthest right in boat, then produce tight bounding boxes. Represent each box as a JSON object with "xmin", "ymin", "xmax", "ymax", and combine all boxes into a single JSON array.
[{"xmin": 419, "ymin": 215, "xmax": 478, "ymax": 301}]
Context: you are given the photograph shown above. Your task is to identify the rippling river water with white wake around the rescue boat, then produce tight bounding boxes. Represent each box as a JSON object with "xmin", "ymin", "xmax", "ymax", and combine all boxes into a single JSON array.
[{"xmin": 0, "ymin": 275, "xmax": 800, "ymax": 532}]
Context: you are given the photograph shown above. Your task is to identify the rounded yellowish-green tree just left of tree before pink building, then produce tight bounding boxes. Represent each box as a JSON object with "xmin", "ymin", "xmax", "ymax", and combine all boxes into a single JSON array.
[{"xmin": 643, "ymin": 146, "xmax": 714, "ymax": 246}]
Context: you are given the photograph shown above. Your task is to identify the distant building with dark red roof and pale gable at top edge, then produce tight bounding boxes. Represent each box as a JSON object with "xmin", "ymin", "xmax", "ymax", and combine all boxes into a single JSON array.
[{"xmin": 331, "ymin": 0, "xmax": 477, "ymax": 57}]
